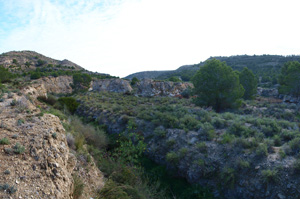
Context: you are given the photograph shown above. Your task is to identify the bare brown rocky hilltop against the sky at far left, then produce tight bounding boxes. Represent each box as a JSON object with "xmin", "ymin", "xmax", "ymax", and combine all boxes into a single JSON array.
[{"xmin": 0, "ymin": 51, "xmax": 83, "ymax": 72}]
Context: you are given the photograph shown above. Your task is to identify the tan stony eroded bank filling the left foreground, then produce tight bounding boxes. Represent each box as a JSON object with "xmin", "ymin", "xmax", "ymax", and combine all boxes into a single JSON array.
[{"xmin": 0, "ymin": 86, "xmax": 104, "ymax": 199}]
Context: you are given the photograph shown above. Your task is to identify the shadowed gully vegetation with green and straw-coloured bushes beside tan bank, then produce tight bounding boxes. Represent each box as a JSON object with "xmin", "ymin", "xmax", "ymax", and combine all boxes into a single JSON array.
[{"xmin": 34, "ymin": 92, "xmax": 212, "ymax": 199}]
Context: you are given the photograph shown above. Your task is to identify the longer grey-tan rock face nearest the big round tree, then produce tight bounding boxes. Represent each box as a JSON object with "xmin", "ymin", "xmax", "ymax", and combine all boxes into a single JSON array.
[{"xmin": 136, "ymin": 79, "xmax": 194, "ymax": 96}]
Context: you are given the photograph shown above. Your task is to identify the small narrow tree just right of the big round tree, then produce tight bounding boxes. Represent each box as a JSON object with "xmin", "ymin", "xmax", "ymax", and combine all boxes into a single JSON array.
[{"xmin": 239, "ymin": 67, "xmax": 257, "ymax": 99}]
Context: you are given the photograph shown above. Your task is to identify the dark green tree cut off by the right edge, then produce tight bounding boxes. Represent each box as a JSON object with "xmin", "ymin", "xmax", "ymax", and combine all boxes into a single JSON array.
[{"xmin": 279, "ymin": 61, "xmax": 300, "ymax": 97}]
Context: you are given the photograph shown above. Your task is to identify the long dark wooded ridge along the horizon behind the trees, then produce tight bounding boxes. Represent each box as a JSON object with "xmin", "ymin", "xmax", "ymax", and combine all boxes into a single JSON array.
[{"xmin": 125, "ymin": 55, "xmax": 300, "ymax": 81}]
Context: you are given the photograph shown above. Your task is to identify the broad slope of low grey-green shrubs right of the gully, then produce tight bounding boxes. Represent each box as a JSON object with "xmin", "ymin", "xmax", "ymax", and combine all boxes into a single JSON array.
[{"xmin": 74, "ymin": 88, "xmax": 300, "ymax": 197}]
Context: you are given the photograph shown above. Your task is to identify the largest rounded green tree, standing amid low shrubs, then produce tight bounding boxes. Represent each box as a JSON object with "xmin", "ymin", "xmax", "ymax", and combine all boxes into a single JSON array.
[{"xmin": 192, "ymin": 59, "xmax": 245, "ymax": 112}]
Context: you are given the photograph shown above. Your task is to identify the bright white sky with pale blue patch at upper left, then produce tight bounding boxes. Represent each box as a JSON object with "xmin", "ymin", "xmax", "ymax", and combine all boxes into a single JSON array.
[{"xmin": 0, "ymin": 0, "xmax": 300, "ymax": 77}]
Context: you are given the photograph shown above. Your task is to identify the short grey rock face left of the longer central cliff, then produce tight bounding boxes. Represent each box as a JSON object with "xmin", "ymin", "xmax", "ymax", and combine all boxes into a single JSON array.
[{"xmin": 92, "ymin": 79, "xmax": 133, "ymax": 93}]
